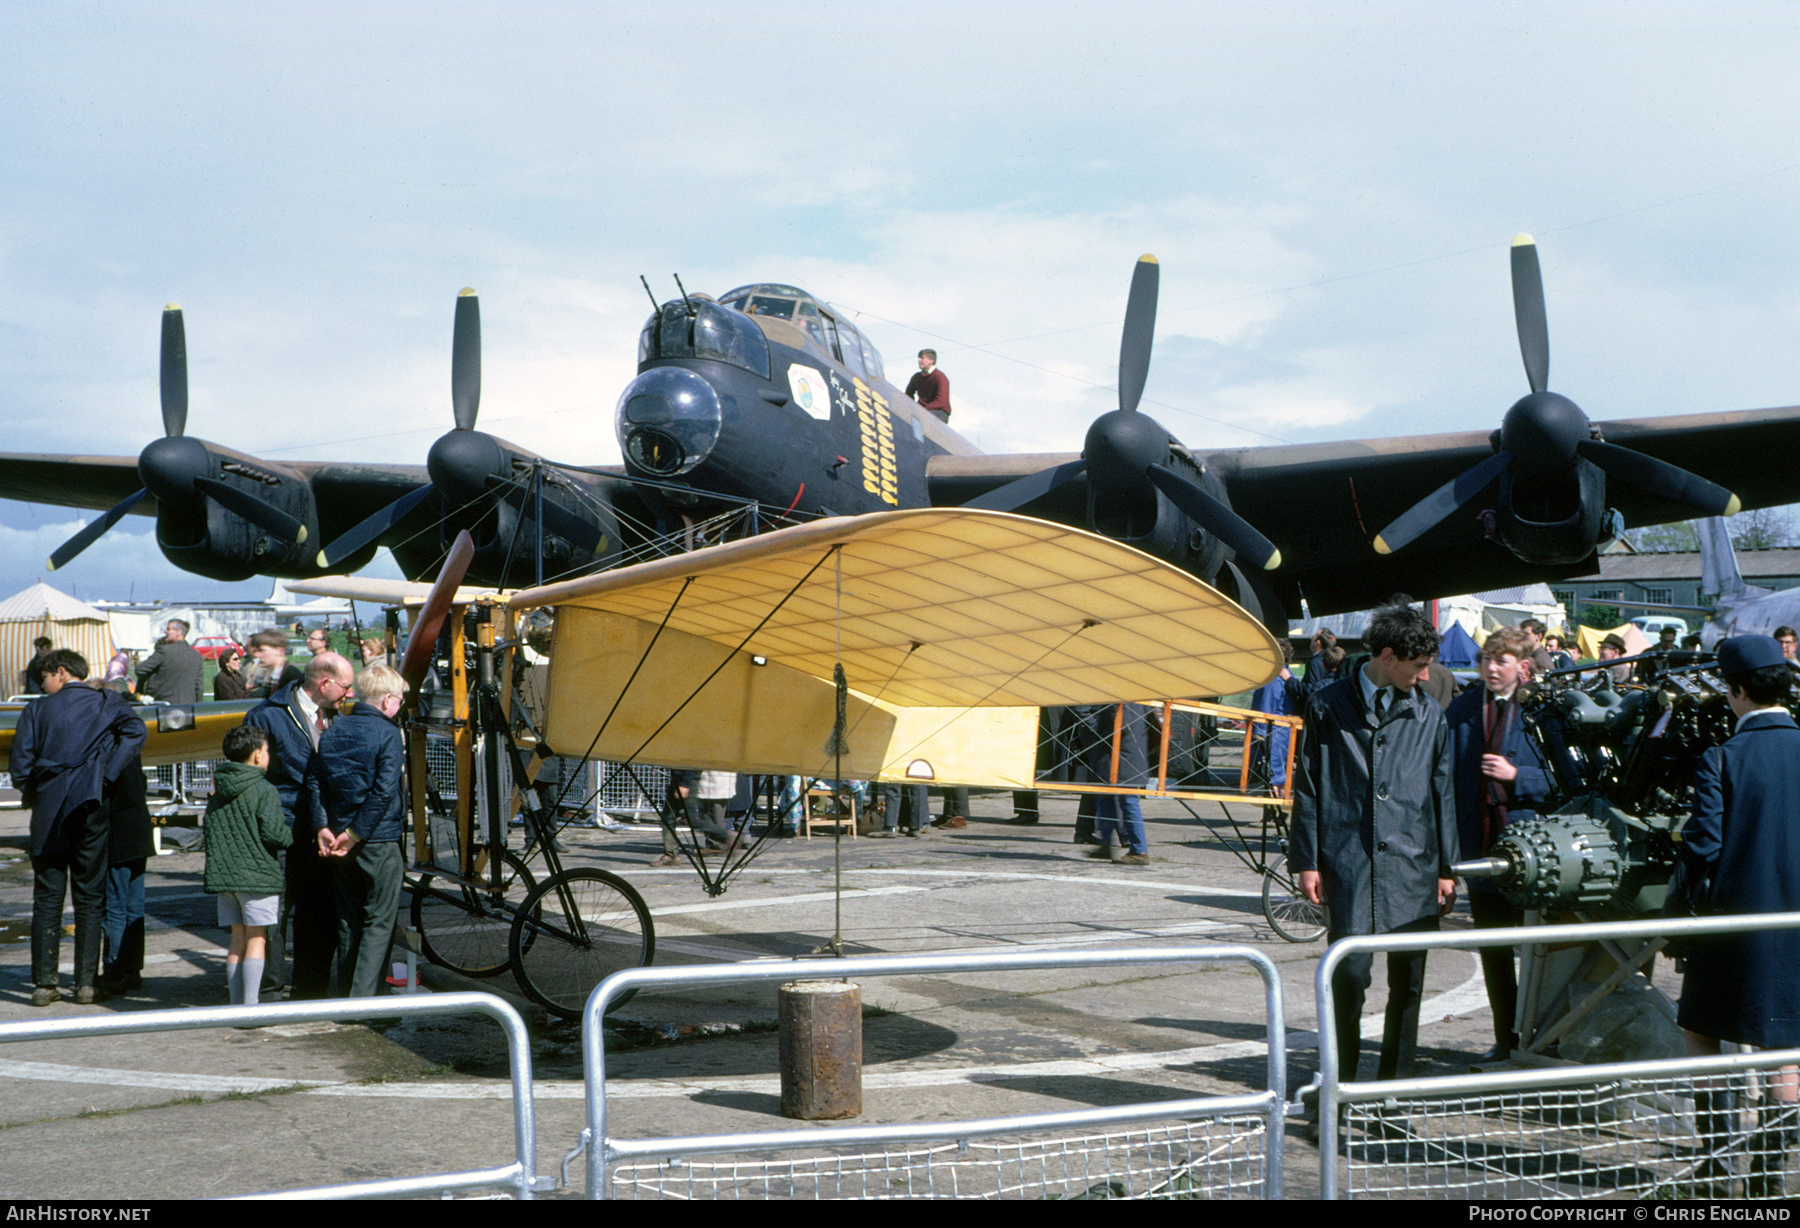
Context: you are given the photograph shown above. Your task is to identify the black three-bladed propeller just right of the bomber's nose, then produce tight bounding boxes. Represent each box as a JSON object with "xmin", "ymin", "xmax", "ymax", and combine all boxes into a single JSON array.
[{"xmin": 965, "ymin": 256, "xmax": 1282, "ymax": 569}]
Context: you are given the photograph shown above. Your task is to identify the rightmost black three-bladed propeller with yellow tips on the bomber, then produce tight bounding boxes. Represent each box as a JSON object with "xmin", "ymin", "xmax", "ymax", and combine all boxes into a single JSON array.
[{"xmin": 1375, "ymin": 234, "xmax": 1741, "ymax": 555}]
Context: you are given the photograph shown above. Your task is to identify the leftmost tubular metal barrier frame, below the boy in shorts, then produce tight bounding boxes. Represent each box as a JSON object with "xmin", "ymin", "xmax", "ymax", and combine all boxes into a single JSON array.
[{"xmin": 0, "ymin": 994, "xmax": 551, "ymax": 1199}]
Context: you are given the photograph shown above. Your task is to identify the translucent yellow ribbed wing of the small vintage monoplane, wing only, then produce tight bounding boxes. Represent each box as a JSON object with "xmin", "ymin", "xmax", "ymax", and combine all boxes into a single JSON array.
[{"xmin": 508, "ymin": 508, "xmax": 1280, "ymax": 708}]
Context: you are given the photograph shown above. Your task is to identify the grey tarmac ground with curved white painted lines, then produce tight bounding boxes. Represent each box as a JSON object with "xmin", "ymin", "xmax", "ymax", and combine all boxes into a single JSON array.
[{"xmin": 0, "ymin": 794, "xmax": 1492, "ymax": 1199}]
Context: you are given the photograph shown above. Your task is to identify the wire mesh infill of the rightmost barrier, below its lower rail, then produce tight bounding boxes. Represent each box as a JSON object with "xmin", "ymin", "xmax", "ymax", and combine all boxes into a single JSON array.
[{"xmin": 1339, "ymin": 1075, "xmax": 1800, "ymax": 1199}]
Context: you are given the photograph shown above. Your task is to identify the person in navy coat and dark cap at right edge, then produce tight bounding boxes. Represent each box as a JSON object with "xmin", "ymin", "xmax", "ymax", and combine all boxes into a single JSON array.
[{"xmin": 1676, "ymin": 636, "xmax": 1800, "ymax": 1197}]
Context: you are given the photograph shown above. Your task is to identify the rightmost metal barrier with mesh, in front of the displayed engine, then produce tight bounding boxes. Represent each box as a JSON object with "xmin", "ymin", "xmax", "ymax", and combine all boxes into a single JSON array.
[{"xmin": 1314, "ymin": 913, "xmax": 1800, "ymax": 1199}]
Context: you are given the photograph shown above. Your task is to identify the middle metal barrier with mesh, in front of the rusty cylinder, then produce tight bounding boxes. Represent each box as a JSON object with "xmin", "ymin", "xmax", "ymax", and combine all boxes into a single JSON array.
[{"xmin": 563, "ymin": 945, "xmax": 1287, "ymax": 1199}]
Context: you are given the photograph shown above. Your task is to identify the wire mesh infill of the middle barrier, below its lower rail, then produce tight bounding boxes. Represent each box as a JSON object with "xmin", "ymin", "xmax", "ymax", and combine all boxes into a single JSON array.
[{"xmin": 608, "ymin": 1116, "xmax": 1267, "ymax": 1199}]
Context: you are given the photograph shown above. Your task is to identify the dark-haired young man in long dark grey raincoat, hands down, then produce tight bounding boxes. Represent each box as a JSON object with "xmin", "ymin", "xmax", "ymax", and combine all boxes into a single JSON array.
[{"xmin": 1287, "ymin": 605, "xmax": 1456, "ymax": 1080}]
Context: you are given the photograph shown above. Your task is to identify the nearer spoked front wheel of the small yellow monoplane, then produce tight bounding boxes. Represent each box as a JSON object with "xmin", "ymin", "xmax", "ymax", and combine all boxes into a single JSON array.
[{"xmin": 508, "ymin": 870, "xmax": 657, "ymax": 1019}]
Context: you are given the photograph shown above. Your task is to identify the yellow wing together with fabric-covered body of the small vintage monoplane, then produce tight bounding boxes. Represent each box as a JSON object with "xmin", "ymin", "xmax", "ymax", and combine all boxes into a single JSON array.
[{"xmin": 508, "ymin": 508, "xmax": 1280, "ymax": 787}]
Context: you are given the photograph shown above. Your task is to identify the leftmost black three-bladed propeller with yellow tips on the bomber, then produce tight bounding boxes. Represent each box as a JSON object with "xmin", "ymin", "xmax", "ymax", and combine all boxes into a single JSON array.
[{"xmin": 45, "ymin": 302, "xmax": 306, "ymax": 571}]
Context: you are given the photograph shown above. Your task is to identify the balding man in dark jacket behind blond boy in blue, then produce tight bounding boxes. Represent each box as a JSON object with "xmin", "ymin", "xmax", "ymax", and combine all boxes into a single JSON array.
[{"xmin": 243, "ymin": 652, "xmax": 353, "ymax": 1001}]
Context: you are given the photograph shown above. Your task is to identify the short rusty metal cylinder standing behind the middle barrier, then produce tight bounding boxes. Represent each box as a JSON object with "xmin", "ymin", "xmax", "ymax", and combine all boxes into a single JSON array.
[{"xmin": 779, "ymin": 981, "xmax": 862, "ymax": 1122}]
